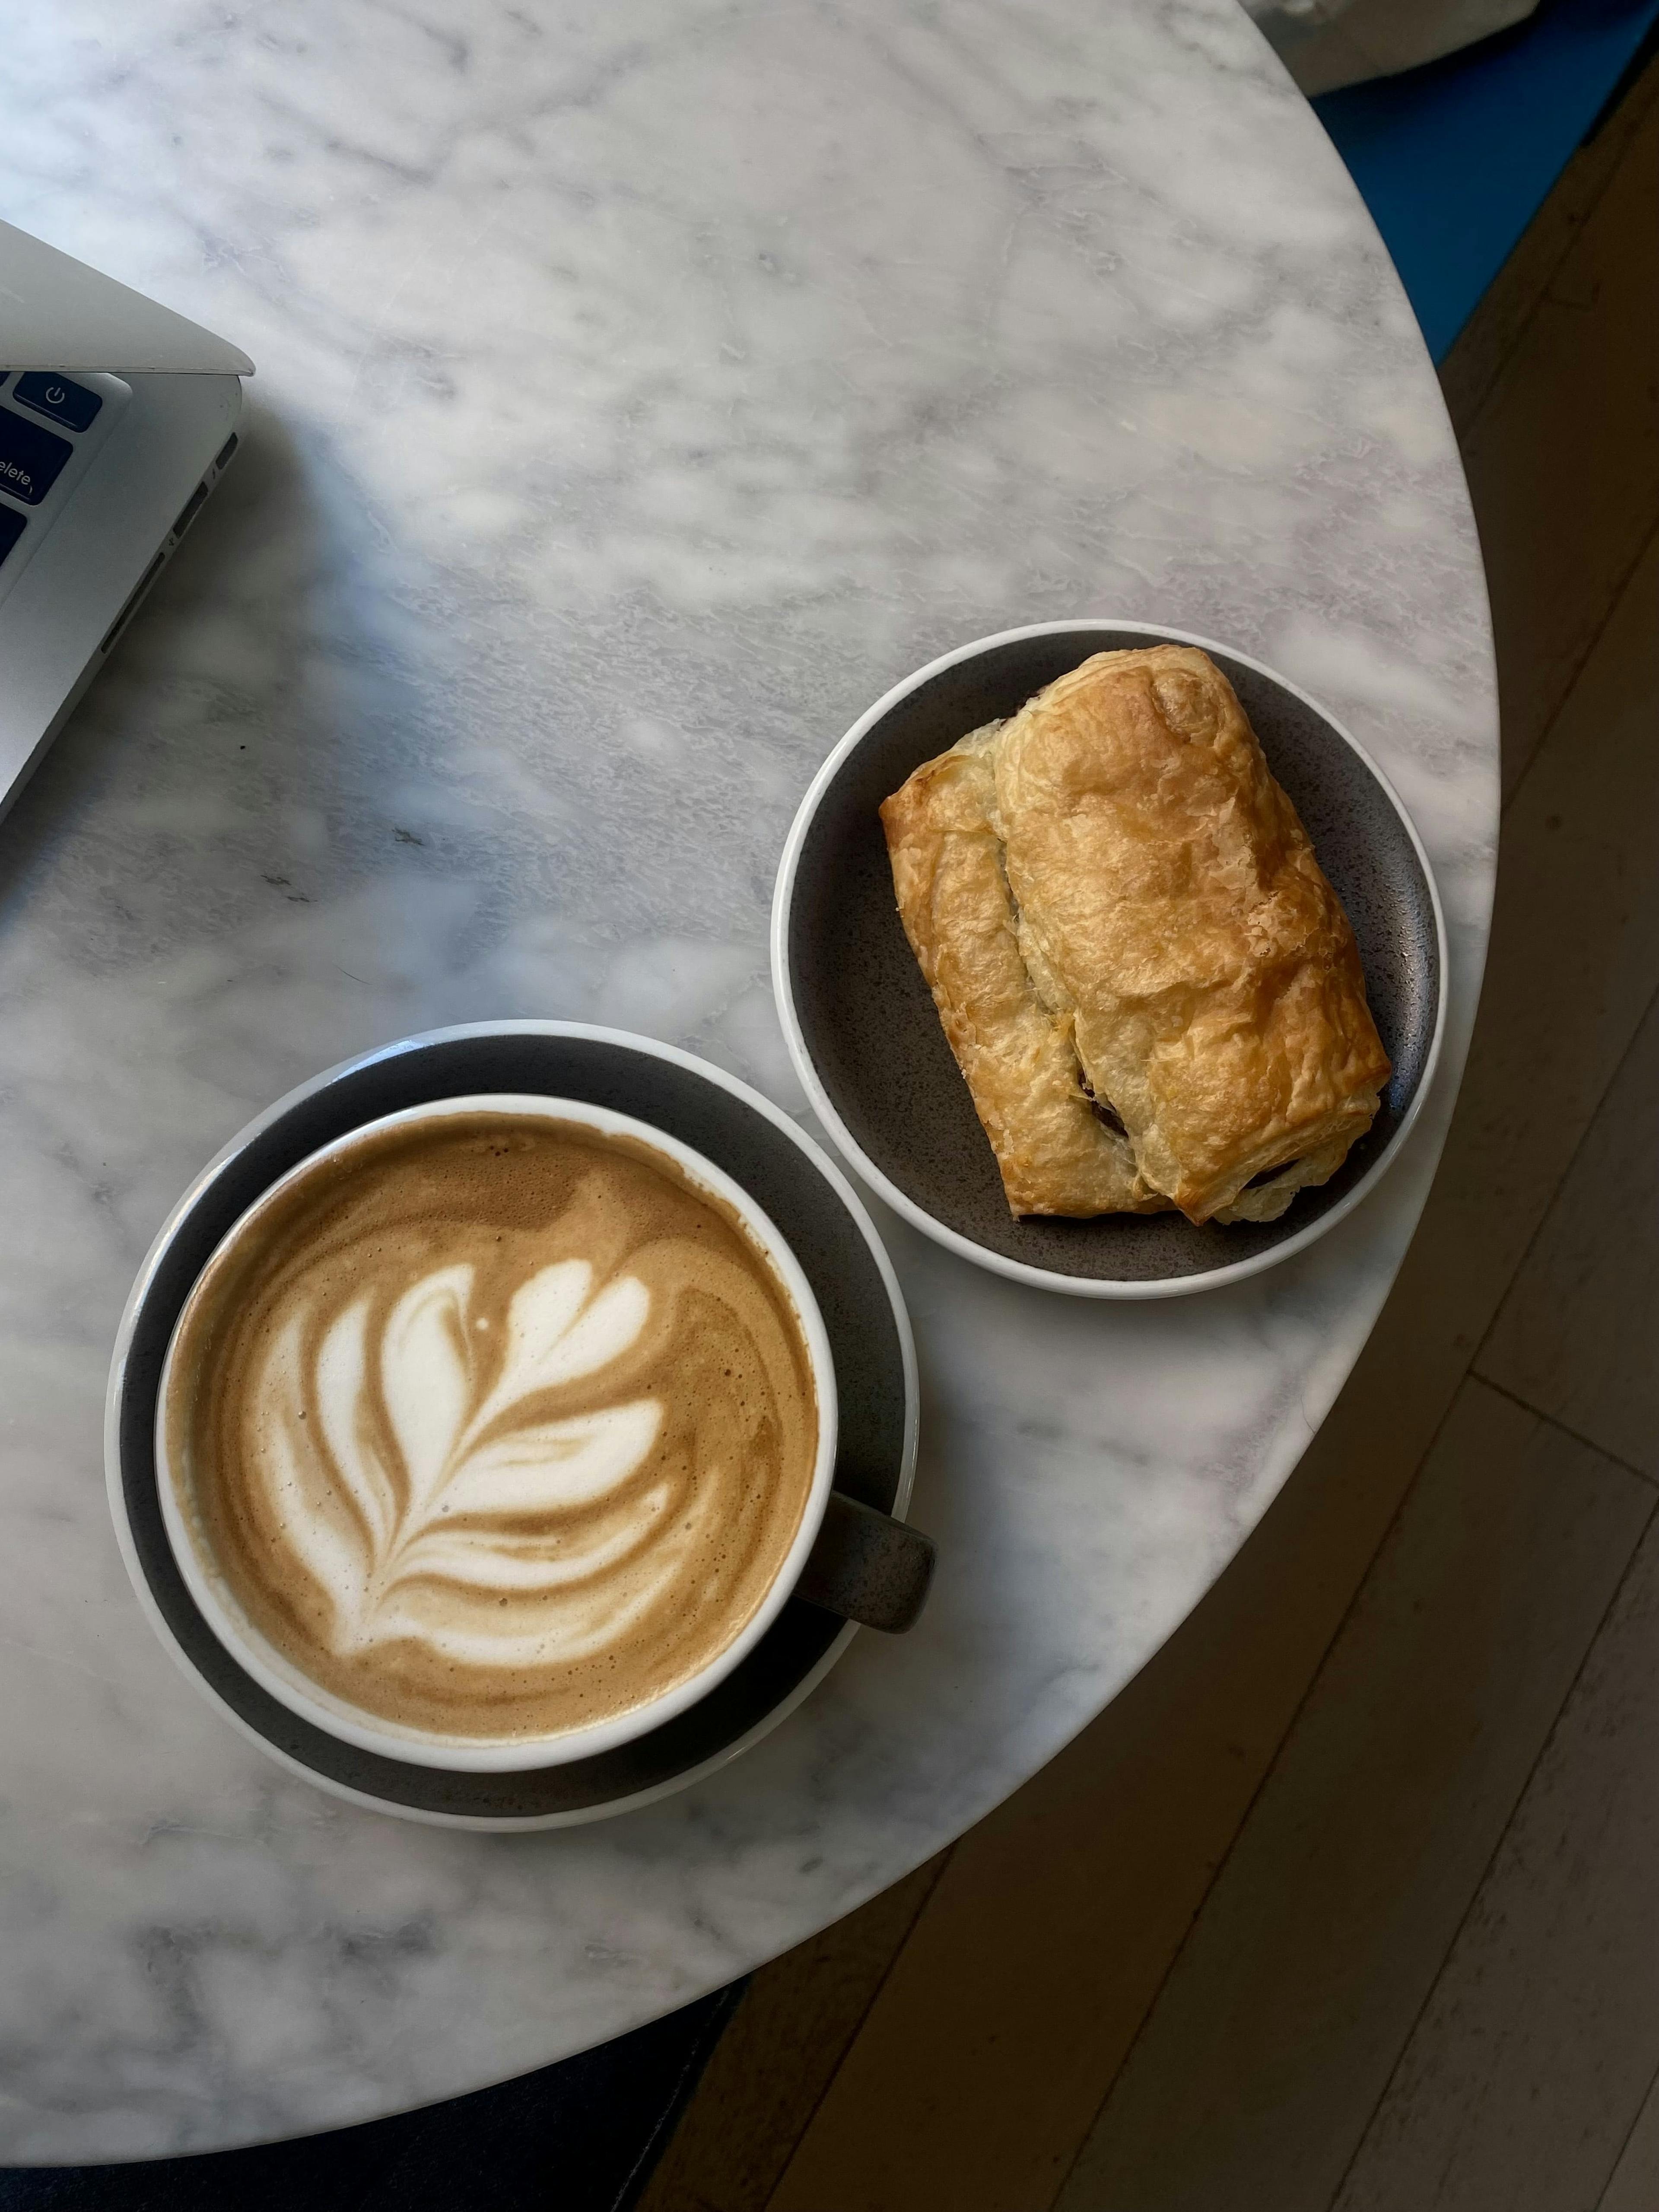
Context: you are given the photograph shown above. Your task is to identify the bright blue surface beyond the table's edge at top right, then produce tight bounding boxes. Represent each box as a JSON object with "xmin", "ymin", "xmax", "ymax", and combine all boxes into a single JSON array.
[{"xmin": 1314, "ymin": 0, "xmax": 1659, "ymax": 361}]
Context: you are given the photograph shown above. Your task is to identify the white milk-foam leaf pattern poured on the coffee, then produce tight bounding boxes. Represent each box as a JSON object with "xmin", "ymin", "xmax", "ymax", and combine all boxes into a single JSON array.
[{"xmin": 265, "ymin": 1259, "xmax": 661, "ymax": 1657}]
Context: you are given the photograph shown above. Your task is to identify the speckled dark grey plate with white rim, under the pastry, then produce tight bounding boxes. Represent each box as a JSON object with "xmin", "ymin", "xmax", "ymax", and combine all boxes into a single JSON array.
[{"xmin": 772, "ymin": 622, "xmax": 1446, "ymax": 1298}]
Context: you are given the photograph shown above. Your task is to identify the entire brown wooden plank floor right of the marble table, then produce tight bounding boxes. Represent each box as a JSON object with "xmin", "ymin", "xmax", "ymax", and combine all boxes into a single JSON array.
[{"xmin": 644, "ymin": 52, "xmax": 1659, "ymax": 2212}]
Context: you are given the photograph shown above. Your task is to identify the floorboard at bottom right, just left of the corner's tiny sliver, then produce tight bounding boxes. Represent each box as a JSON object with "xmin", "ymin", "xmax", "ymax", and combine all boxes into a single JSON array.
[{"xmin": 1338, "ymin": 1529, "xmax": 1659, "ymax": 2212}]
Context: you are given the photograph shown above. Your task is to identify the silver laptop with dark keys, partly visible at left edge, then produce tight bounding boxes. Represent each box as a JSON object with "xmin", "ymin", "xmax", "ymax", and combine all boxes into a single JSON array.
[{"xmin": 0, "ymin": 223, "xmax": 254, "ymax": 814}]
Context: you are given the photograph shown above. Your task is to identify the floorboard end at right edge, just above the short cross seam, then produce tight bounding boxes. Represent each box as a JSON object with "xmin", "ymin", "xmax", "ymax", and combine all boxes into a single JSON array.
[{"xmin": 1475, "ymin": 991, "xmax": 1659, "ymax": 1475}]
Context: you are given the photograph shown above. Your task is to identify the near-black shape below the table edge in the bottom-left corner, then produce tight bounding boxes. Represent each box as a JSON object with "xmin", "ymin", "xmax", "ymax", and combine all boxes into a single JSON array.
[{"xmin": 0, "ymin": 1982, "xmax": 745, "ymax": 2212}]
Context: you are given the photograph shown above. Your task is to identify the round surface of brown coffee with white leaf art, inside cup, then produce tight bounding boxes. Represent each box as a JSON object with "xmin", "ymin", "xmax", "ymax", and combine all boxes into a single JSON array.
[{"xmin": 164, "ymin": 1110, "xmax": 818, "ymax": 1741}]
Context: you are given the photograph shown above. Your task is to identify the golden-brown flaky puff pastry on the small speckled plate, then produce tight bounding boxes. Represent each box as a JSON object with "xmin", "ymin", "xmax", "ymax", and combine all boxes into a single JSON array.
[{"xmin": 880, "ymin": 646, "xmax": 1389, "ymax": 1221}]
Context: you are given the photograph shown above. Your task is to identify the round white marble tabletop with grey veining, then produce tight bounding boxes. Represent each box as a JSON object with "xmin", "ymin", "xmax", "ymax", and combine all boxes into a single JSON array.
[{"xmin": 0, "ymin": 0, "xmax": 1495, "ymax": 2161}]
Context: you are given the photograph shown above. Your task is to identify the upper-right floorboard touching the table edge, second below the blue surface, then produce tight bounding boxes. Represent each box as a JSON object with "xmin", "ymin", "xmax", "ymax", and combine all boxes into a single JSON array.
[{"xmin": 1462, "ymin": 69, "xmax": 1659, "ymax": 790}]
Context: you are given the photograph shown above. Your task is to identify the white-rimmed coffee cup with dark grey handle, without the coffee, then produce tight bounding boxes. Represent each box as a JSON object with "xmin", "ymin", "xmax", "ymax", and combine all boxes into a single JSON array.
[{"xmin": 155, "ymin": 1093, "xmax": 934, "ymax": 1774}]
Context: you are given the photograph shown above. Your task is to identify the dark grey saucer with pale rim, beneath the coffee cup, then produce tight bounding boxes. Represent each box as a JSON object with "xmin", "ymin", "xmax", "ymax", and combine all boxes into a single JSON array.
[{"xmin": 104, "ymin": 1022, "xmax": 918, "ymax": 1829}]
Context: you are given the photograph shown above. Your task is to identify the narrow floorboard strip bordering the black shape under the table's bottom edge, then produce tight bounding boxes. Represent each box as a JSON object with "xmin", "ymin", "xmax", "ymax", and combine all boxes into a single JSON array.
[{"xmin": 635, "ymin": 1854, "xmax": 944, "ymax": 2212}]
